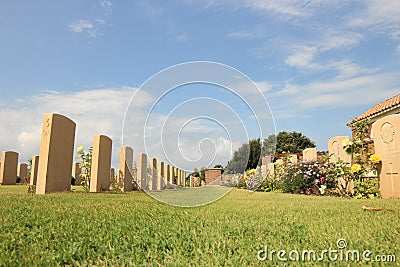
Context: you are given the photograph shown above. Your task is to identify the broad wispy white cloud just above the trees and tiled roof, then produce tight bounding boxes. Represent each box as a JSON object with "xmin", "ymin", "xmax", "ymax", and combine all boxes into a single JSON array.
[{"xmin": 271, "ymin": 73, "xmax": 400, "ymax": 117}]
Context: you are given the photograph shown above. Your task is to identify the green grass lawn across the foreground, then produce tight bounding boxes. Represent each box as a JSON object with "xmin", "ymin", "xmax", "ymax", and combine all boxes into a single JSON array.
[{"xmin": 0, "ymin": 186, "xmax": 400, "ymax": 266}]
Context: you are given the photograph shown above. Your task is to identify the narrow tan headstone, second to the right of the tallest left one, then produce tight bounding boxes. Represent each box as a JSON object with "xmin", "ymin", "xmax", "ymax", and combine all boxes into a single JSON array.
[{"xmin": 119, "ymin": 146, "xmax": 133, "ymax": 192}]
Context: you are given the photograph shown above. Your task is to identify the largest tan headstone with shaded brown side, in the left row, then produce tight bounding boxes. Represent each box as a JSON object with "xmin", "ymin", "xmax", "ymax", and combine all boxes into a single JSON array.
[{"xmin": 36, "ymin": 114, "xmax": 76, "ymax": 194}]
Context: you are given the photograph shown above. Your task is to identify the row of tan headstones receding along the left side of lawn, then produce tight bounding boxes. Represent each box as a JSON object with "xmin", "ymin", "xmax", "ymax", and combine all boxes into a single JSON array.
[{"xmin": 0, "ymin": 114, "xmax": 191, "ymax": 194}]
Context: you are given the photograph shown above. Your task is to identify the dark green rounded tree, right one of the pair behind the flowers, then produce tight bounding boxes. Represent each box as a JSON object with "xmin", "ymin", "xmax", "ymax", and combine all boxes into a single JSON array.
[{"xmin": 276, "ymin": 131, "xmax": 315, "ymax": 153}]
